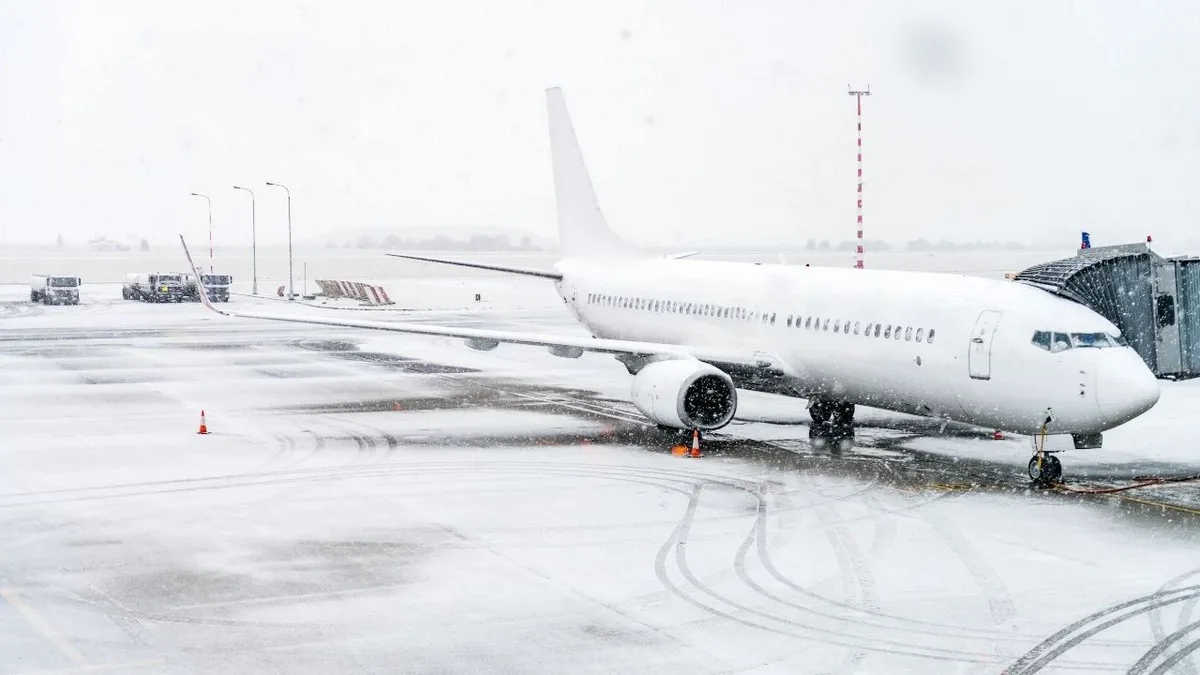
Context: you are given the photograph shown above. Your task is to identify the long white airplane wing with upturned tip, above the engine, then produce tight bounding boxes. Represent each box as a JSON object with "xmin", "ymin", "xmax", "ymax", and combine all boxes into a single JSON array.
[{"xmin": 180, "ymin": 235, "xmax": 779, "ymax": 369}]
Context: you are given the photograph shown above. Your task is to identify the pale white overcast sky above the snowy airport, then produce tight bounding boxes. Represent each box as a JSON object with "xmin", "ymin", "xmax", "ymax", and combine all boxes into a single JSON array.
[{"xmin": 0, "ymin": 0, "xmax": 1200, "ymax": 245}]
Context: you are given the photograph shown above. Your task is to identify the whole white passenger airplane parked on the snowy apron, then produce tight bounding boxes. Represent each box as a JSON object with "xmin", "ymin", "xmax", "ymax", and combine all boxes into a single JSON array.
[{"xmin": 180, "ymin": 88, "xmax": 1159, "ymax": 484}]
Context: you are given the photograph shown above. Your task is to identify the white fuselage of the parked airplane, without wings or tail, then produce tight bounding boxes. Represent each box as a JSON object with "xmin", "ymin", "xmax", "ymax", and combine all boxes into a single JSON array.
[{"xmin": 557, "ymin": 258, "xmax": 1159, "ymax": 435}]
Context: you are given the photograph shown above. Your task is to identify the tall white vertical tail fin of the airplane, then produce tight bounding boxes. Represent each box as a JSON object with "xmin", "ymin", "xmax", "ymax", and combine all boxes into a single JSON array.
[{"xmin": 546, "ymin": 86, "xmax": 638, "ymax": 257}]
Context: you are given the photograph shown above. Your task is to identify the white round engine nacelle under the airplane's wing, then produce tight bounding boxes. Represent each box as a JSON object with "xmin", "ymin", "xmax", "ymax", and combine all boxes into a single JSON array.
[{"xmin": 632, "ymin": 359, "xmax": 738, "ymax": 429}]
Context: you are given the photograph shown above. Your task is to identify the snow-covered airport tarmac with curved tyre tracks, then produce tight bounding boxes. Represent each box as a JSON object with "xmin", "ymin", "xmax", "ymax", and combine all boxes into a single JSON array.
[{"xmin": 0, "ymin": 281, "xmax": 1200, "ymax": 674}]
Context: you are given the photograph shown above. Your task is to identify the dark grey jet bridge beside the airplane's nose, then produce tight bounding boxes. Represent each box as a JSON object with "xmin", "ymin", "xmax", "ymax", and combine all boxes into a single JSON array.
[{"xmin": 1014, "ymin": 244, "xmax": 1200, "ymax": 380}]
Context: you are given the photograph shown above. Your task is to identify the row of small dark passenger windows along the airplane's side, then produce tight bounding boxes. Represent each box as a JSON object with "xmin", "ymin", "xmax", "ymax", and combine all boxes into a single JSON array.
[{"xmin": 588, "ymin": 293, "xmax": 935, "ymax": 342}]
